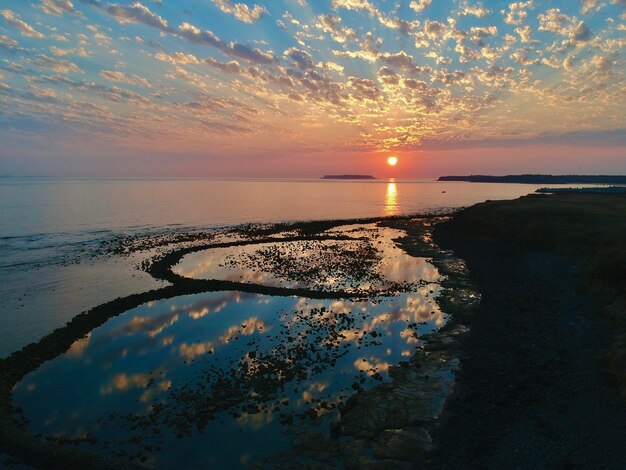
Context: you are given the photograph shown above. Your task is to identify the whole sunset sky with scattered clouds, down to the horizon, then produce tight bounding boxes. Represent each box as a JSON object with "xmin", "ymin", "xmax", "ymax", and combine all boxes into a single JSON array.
[{"xmin": 0, "ymin": 0, "xmax": 626, "ymax": 178}]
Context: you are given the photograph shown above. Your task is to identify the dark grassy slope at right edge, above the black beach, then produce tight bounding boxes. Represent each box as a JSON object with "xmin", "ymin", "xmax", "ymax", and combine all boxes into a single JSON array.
[{"xmin": 438, "ymin": 193, "xmax": 626, "ymax": 398}]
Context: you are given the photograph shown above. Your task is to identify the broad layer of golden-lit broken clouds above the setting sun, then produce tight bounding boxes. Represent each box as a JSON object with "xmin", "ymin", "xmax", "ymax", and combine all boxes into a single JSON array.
[{"xmin": 0, "ymin": 0, "xmax": 624, "ymax": 163}]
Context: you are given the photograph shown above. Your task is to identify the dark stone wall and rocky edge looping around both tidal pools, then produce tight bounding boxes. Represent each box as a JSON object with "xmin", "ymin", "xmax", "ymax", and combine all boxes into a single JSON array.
[{"xmin": 0, "ymin": 215, "xmax": 472, "ymax": 468}]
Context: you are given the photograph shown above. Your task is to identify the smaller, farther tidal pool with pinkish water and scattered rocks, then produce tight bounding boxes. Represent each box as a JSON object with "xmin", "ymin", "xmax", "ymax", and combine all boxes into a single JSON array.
[{"xmin": 172, "ymin": 224, "xmax": 438, "ymax": 291}]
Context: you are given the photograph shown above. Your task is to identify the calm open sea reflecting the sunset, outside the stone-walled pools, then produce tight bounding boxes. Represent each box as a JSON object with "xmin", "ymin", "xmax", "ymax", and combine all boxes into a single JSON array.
[{"xmin": 0, "ymin": 178, "xmax": 537, "ymax": 356}]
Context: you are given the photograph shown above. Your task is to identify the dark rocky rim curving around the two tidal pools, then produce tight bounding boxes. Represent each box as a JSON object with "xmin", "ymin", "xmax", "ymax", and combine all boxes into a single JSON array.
[{"xmin": 0, "ymin": 216, "xmax": 476, "ymax": 468}]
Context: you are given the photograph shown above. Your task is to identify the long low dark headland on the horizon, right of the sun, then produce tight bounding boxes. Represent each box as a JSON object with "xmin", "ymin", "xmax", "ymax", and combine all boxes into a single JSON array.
[{"xmin": 438, "ymin": 175, "xmax": 626, "ymax": 184}]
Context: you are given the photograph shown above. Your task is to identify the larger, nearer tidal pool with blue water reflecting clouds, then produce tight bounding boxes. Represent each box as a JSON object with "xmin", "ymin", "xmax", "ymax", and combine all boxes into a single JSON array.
[{"xmin": 13, "ymin": 284, "xmax": 446, "ymax": 468}]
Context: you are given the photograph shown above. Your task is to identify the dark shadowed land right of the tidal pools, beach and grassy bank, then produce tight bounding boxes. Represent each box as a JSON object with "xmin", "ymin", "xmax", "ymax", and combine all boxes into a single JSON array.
[{"xmin": 429, "ymin": 195, "xmax": 626, "ymax": 469}]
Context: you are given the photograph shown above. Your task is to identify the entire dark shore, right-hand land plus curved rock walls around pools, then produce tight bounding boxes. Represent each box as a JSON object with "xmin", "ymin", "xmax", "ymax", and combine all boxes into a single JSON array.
[{"xmin": 0, "ymin": 195, "xmax": 626, "ymax": 468}]
